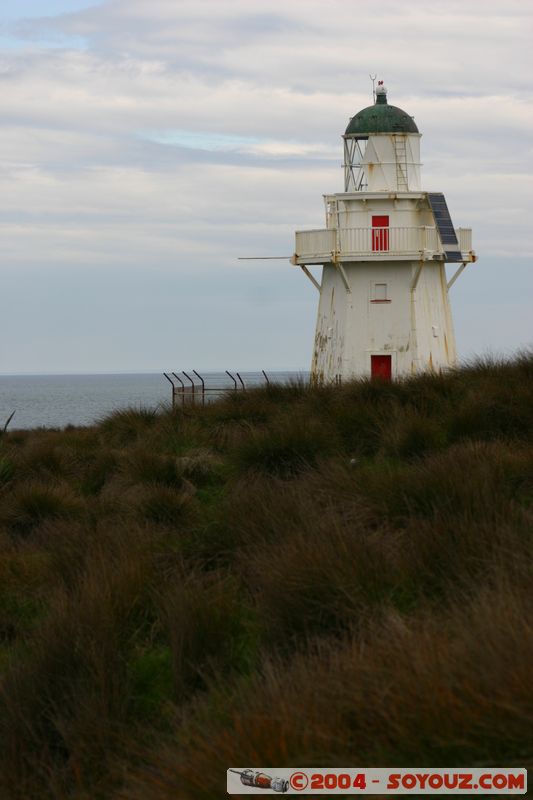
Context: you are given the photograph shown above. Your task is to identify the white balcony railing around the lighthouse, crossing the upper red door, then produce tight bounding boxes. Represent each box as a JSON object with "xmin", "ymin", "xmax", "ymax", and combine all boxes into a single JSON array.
[{"xmin": 296, "ymin": 227, "xmax": 472, "ymax": 261}]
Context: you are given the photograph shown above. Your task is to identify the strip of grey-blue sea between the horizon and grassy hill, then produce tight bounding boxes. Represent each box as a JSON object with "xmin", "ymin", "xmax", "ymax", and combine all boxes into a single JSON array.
[{"xmin": 0, "ymin": 371, "xmax": 309, "ymax": 431}]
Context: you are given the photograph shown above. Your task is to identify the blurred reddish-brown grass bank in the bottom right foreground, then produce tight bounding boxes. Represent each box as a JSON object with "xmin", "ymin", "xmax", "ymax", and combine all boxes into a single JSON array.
[{"xmin": 120, "ymin": 576, "xmax": 533, "ymax": 800}]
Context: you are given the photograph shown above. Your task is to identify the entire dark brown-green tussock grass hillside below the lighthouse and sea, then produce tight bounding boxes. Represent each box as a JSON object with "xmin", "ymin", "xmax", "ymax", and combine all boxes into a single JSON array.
[{"xmin": 0, "ymin": 353, "xmax": 533, "ymax": 800}]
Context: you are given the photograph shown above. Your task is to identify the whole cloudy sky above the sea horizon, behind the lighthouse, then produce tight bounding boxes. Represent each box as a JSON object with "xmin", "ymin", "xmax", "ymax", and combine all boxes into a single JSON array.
[{"xmin": 0, "ymin": 0, "xmax": 533, "ymax": 374}]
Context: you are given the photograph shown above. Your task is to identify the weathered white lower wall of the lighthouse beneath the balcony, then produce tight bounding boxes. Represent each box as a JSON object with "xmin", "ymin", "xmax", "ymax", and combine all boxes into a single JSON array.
[{"xmin": 312, "ymin": 261, "xmax": 456, "ymax": 380}]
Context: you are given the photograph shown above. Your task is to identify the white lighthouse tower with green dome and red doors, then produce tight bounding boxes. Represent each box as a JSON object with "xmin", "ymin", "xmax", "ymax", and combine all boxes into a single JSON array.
[{"xmin": 292, "ymin": 81, "xmax": 476, "ymax": 382}]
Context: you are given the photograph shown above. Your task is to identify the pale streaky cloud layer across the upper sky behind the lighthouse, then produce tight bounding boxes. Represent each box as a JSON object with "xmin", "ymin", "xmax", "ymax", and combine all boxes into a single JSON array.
[{"xmin": 0, "ymin": 0, "xmax": 533, "ymax": 369}]
